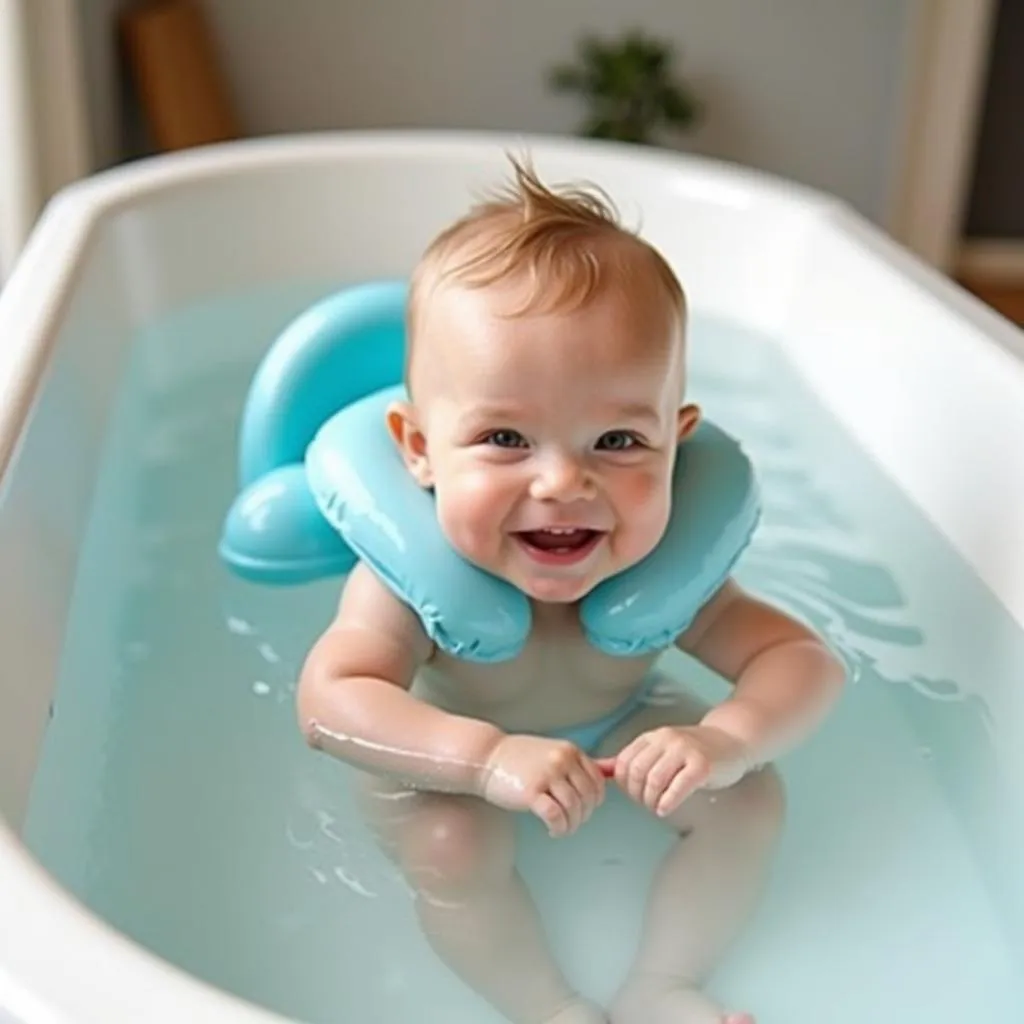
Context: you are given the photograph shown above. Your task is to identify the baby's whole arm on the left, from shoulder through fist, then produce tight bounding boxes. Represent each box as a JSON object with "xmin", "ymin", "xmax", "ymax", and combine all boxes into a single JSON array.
[{"xmin": 297, "ymin": 564, "xmax": 604, "ymax": 835}]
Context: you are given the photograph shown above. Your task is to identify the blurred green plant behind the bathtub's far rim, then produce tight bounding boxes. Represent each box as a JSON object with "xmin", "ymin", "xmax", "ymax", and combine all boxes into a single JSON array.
[{"xmin": 548, "ymin": 30, "xmax": 701, "ymax": 145}]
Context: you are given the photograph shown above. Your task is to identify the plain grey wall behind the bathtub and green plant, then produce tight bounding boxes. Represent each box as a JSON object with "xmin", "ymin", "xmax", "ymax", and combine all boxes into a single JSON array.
[{"xmin": 82, "ymin": 0, "xmax": 915, "ymax": 220}]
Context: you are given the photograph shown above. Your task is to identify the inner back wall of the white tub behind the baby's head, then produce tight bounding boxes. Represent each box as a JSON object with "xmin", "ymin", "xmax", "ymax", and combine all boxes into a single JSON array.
[{"xmin": 90, "ymin": 146, "xmax": 827, "ymax": 325}]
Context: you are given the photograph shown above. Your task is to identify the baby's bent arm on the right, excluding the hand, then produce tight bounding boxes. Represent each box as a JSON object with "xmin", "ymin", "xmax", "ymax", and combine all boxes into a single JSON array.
[{"xmin": 677, "ymin": 580, "xmax": 846, "ymax": 765}]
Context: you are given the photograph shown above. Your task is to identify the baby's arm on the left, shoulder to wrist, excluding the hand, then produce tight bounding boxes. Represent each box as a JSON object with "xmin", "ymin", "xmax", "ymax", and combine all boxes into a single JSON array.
[{"xmin": 297, "ymin": 563, "xmax": 503, "ymax": 793}]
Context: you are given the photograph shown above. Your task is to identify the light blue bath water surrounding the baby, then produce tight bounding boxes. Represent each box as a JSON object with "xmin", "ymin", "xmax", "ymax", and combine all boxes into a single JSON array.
[{"xmin": 19, "ymin": 285, "xmax": 1024, "ymax": 1024}]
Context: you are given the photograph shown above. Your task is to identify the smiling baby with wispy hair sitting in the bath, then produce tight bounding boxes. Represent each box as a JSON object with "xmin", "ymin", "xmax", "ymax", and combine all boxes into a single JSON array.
[{"xmin": 297, "ymin": 153, "xmax": 844, "ymax": 1024}]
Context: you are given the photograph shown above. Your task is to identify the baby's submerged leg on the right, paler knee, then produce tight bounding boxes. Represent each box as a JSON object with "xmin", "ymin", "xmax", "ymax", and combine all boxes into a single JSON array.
[{"xmin": 602, "ymin": 697, "xmax": 784, "ymax": 1024}]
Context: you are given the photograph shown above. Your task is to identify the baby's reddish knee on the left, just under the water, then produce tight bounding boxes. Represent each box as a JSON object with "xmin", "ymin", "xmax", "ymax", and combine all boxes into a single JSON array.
[{"xmin": 397, "ymin": 797, "xmax": 514, "ymax": 891}]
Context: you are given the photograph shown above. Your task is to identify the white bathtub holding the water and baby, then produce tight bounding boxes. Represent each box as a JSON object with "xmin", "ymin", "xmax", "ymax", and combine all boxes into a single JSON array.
[{"xmin": 0, "ymin": 134, "xmax": 1024, "ymax": 1024}]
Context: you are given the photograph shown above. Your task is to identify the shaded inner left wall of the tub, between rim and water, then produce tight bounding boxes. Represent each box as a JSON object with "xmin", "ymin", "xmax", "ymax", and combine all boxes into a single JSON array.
[{"xmin": 0, "ymin": 222, "xmax": 144, "ymax": 826}]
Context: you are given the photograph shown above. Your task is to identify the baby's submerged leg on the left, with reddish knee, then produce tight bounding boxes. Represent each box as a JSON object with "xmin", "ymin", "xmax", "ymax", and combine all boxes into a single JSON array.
[{"xmin": 360, "ymin": 778, "xmax": 607, "ymax": 1024}]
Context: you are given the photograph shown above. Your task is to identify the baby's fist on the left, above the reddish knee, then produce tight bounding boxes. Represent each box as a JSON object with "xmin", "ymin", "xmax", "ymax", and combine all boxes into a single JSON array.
[{"xmin": 482, "ymin": 735, "xmax": 604, "ymax": 836}]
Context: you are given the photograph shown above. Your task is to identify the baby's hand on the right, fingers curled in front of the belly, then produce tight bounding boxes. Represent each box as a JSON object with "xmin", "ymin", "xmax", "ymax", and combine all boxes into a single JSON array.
[{"xmin": 599, "ymin": 725, "xmax": 749, "ymax": 817}]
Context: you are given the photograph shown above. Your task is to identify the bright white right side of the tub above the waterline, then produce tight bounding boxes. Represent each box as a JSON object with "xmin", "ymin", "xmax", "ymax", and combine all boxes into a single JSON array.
[{"xmin": 774, "ymin": 213, "xmax": 1024, "ymax": 663}]
